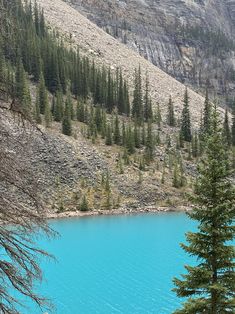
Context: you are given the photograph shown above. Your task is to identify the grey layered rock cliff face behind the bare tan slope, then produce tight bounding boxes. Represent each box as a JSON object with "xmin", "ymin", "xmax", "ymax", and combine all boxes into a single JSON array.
[{"xmin": 67, "ymin": 0, "xmax": 235, "ymax": 103}]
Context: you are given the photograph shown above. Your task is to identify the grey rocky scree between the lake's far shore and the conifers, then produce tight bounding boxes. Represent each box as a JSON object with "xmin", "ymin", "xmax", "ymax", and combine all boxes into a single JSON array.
[{"xmin": 0, "ymin": 105, "xmax": 191, "ymax": 215}]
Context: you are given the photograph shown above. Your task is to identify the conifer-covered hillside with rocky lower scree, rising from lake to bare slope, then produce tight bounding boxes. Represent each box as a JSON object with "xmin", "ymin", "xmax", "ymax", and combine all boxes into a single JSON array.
[{"xmin": 0, "ymin": 0, "xmax": 235, "ymax": 216}]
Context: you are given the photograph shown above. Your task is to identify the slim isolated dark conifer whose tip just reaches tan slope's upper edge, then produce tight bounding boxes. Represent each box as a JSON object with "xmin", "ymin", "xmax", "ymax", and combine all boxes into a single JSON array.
[{"xmin": 180, "ymin": 88, "xmax": 192, "ymax": 142}]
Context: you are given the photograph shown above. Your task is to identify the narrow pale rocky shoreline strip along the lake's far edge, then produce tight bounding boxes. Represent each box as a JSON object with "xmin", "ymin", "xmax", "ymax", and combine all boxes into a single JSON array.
[{"xmin": 47, "ymin": 206, "xmax": 190, "ymax": 219}]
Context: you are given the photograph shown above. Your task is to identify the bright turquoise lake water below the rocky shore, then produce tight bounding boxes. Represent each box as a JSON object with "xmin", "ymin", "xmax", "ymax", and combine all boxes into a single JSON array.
[{"xmin": 25, "ymin": 213, "xmax": 195, "ymax": 314}]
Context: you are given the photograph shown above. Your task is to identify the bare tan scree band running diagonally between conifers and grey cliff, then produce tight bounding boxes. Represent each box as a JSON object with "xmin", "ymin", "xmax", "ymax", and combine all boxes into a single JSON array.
[{"xmin": 35, "ymin": 0, "xmax": 221, "ymax": 123}]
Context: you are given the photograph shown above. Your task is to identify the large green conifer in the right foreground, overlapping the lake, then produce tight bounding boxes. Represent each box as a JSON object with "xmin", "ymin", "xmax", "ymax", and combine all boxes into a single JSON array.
[{"xmin": 174, "ymin": 108, "xmax": 235, "ymax": 314}]
